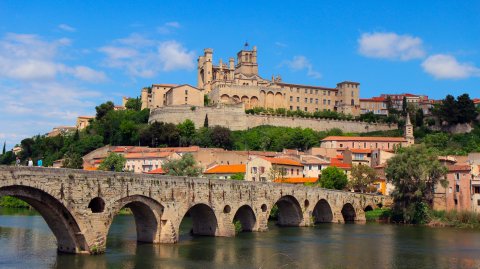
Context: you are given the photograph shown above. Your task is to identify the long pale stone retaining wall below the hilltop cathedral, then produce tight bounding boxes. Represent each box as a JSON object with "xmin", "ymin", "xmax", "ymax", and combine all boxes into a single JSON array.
[{"xmin": 148, "ymin": 104, "xmax": 396, "ymax": 133}]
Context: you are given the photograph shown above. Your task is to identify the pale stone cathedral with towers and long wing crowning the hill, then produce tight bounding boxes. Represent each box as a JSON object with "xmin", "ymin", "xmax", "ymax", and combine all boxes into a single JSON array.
[{"xmin": 141, "ymin": 44, "xmax": 360, "ymax": 116}]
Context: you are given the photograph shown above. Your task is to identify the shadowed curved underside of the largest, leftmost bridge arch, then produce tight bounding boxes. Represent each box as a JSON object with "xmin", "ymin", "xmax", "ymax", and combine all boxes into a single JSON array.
[{"xmin": 0, "ymin": 185, "xmax": 89, "ymax": 253}]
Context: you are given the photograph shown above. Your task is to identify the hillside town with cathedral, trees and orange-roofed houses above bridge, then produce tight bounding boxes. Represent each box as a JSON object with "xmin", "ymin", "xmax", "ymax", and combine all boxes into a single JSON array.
[{"xmin": 0, "ymin": 44, "xmax": 480, "ymax": 216}]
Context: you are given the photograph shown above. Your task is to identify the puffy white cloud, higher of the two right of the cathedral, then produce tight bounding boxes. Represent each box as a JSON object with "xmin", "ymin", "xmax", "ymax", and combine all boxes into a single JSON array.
[{"xmin": 358, "ymin": 33, "xmax": 425, "ymax": 61}]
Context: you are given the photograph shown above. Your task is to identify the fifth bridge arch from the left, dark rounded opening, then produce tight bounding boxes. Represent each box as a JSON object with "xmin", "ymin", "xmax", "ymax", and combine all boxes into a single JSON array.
[{"xmin": 275, "ymin": 195, "xmax": 303, "ymax": 226}]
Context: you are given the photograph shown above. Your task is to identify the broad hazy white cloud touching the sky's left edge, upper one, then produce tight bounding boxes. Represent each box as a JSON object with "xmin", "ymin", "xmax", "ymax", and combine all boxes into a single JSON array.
[{"xmin": 0, "ymin": 33, "xmax": 106, "ymax": 82}]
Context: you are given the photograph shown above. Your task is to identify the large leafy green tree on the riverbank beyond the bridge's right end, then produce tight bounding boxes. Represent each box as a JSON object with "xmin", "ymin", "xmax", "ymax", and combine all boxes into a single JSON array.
[{"xmin": 385, "ymin": 145, "xmax": 447, "ymax": 223}]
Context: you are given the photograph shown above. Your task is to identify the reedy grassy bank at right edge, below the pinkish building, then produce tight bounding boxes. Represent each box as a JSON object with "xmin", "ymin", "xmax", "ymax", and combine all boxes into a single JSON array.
[{"xmin": 428, "ymin": 210, "xmax": 480, "ymax": 228}]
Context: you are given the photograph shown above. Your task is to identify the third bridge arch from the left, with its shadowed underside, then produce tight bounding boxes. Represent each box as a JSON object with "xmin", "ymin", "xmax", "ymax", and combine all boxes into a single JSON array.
[{"xmin": 177, "ymin": 203, "xmax": 218, "ymax": 236}]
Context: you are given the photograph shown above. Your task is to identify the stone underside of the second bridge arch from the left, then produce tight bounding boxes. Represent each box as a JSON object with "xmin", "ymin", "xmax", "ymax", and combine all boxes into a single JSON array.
[{"xmin": 109, "ymin": 195, "xmax": 164, "ymax": 243}]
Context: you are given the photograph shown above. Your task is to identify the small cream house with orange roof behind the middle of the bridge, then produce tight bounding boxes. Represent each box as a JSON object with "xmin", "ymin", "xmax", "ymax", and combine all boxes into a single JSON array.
[{"xmin": 245, "ymin": 156, "xmax": 303, "ymax": 182}]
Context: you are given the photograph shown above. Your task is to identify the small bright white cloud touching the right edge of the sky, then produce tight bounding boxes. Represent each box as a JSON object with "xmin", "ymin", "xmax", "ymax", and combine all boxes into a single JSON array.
[{"xmin": 422, "ymin": 54, "xmax": 480, "ymax": 79}]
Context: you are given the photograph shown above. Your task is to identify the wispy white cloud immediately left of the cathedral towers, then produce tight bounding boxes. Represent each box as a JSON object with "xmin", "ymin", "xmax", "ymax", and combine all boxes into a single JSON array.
[{"xmin": 99, "ymin": 34, "xmax": 196, "ymax": 78}]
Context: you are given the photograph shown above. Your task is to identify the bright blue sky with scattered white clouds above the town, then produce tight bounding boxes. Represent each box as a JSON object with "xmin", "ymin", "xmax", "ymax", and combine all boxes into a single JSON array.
[{"xmin": 0, "ymin": 0, "xmax": 480, "ymax": 149}]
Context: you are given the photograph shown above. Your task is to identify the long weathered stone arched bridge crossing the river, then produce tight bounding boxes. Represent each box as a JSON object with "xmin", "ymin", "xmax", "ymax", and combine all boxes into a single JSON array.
[{"xmin": 0, "ymin": 166, "xmax": 392, "ymax": 254}]
